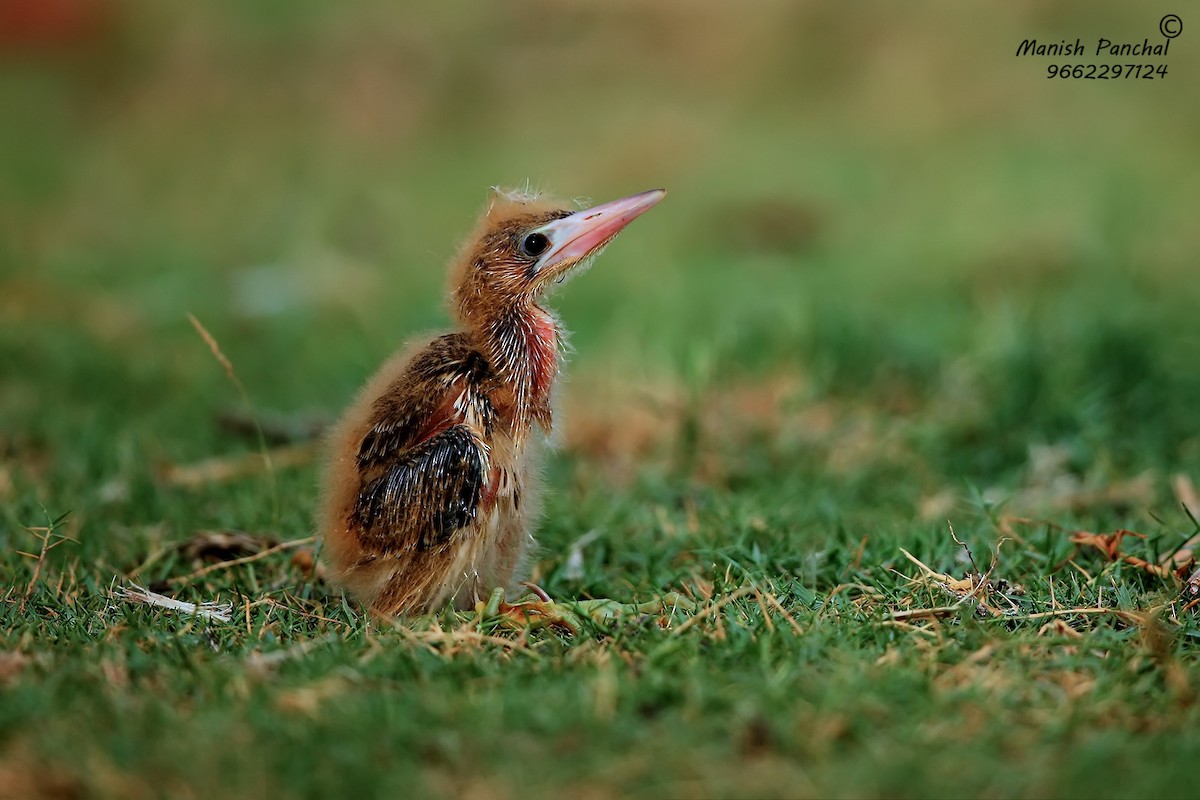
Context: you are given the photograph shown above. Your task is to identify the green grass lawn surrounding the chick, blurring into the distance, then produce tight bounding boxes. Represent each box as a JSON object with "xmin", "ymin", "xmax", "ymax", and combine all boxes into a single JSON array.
[{"xmin": 0, "ymin": 2, "xmax": 1200, "ymax": 798}]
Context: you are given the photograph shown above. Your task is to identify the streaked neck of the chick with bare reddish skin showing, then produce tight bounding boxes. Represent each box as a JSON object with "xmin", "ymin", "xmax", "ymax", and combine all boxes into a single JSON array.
[{"xmin": 479, "ymin": 302, "xmax": 559, "ymax": 429}]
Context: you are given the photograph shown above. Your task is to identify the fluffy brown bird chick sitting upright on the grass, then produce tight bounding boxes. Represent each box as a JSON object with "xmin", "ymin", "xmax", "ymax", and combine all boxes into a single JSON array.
[{"xmin": 318, "ymin": 190, "xmax": 665, "ymax": 614}]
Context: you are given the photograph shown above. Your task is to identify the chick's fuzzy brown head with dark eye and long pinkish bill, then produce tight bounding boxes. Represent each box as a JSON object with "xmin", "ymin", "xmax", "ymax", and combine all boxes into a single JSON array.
[{"xmin": 451, "ymin": 190, "xmax": 666, "ymax": 325}]
